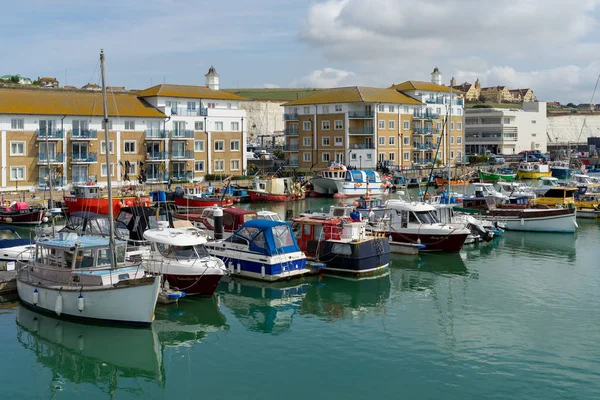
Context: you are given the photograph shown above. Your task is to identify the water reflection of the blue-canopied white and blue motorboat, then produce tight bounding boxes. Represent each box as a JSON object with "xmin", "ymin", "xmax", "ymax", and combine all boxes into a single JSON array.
[{"xmin": 216, "ymin": 279, "xmax": 307, "ymax": 334}]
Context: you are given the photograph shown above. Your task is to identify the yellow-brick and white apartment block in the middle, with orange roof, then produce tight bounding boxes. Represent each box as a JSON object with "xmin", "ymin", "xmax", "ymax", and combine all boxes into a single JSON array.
[{"xmin": 284, "ymin": 71, "xmax": 464, "ymax": 169}]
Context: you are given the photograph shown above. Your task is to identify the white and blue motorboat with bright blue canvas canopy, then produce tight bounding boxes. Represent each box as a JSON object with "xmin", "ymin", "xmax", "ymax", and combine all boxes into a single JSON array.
[{"xmin": 206, "ymin": 220, "xmax": 309, "ymax": 282}]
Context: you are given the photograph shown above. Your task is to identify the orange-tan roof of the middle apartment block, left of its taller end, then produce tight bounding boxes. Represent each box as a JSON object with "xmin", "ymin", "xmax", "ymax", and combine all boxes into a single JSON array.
[{"xmin": 284, "ymin": 86, "xmax": 422, "ymax": 106}]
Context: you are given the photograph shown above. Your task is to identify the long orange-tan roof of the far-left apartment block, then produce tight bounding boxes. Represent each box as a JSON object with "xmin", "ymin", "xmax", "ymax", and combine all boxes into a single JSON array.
[{"xmin": 0, "ymin": 88, "xmax": 165, "ymax": 118}]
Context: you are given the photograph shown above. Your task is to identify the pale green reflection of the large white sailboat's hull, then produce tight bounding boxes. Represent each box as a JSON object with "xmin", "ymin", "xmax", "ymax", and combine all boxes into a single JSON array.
[{"xmin": 16, "ymin": 304, "xmax": 165, "ymax": 395}]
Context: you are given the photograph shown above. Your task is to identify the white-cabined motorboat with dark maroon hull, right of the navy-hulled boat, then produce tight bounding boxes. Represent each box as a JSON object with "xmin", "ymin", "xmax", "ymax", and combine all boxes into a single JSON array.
[{"xmin": 373, "ymin": 200, "xmax": 471, "ymax": 253}]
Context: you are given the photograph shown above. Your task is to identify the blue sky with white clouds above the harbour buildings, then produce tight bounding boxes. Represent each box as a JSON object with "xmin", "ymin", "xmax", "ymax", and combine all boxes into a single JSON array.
[{"xmin": 0, "ymin": 0, "xmax": 600, "ymax": 103}]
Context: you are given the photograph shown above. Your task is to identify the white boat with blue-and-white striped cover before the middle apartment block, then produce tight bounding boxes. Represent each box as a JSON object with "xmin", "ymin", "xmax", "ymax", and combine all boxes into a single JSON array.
[{"xmin": 311, "ymin": 166, "xmax": 391, "ymax": 198}]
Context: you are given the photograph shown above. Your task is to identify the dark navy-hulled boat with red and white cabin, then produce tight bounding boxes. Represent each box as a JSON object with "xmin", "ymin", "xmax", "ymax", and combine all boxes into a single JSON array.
[{"xmin": 292, "ymin": 216, "xmax": 390, "ymax": 276}]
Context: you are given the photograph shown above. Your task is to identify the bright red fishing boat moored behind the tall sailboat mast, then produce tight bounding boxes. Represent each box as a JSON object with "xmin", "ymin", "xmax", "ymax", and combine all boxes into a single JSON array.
[{"xmin": 64, "ymin": 185, "xmax": 152, "ymax": 219}]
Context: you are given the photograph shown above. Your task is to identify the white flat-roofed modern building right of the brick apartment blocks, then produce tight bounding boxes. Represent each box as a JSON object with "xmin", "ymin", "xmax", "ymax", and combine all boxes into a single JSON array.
[{"xmin": 465, "ymin": 102, "xmax": 548, "ymax": 154}]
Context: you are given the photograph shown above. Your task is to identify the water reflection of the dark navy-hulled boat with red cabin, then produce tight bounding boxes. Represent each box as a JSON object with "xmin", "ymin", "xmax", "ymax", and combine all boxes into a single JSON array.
[{"xmin": 300, "ymin": 271, "xmax": 391, "ymax": 320}]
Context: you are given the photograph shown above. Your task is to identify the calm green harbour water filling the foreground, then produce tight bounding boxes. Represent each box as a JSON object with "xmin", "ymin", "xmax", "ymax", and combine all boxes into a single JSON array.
[{"xmin": 0, "ymin": 200, "xmax": 600, "ymax": 399}]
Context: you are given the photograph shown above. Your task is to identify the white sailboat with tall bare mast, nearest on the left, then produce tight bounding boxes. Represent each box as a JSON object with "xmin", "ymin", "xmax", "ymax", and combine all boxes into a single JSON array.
[{"xmin": 17, "ymin": 51, "xmax": 160, "ymax": 325}]
